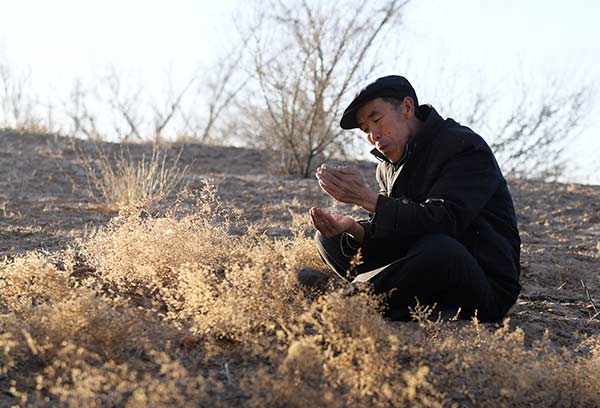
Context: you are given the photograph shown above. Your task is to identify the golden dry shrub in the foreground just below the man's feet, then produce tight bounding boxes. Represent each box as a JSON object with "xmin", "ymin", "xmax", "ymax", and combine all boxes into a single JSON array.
[{"xmin": 246, "ymin": 292, "xmax": 442, "ymax": 407}]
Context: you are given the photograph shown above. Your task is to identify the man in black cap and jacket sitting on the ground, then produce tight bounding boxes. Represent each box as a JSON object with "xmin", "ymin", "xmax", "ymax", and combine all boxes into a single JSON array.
[{"xmin": 310, "ymin": 76, "xmax": 520, "ymax": 321}]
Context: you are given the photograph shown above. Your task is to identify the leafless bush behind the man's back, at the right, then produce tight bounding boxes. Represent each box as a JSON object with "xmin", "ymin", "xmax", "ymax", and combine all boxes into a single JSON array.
[{"xmin": 428, "ymin": 68, "xmax": 595, "ymax": 181}]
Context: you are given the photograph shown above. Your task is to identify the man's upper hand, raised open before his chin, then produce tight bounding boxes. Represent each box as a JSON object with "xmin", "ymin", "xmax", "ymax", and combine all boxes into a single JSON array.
[{"xmin": 316, "ymin": 164, "xmax": 377, "ymax": 212}]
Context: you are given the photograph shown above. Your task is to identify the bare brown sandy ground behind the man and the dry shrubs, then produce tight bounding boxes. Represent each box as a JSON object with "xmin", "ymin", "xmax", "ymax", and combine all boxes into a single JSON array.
[{"xmin": 0, "ymin": 131, "xmax": 600, "ymax": 346}]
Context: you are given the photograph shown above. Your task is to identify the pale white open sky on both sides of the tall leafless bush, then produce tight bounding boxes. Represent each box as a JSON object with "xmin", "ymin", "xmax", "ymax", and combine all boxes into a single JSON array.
[{"xmin": 0, "ymin": 0, "xmax": 600, "ymax": 183}]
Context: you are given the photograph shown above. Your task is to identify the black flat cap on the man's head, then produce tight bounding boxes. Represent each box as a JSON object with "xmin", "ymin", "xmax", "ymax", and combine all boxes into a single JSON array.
[{"xmin": 340, "ymin": 75, "xmax": 419, "ymax": 129}]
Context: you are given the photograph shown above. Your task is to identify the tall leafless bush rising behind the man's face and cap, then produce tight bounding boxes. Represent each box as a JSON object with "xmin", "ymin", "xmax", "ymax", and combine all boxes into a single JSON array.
[{"xmin": 237, "ymin": 0, "xmax": 407, "ymax": 177}]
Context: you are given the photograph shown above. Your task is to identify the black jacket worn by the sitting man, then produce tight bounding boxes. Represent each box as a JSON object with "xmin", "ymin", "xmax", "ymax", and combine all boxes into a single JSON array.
[{"xmin": 361, "ymin": 105, "xmax": 521, "ymax": 310}]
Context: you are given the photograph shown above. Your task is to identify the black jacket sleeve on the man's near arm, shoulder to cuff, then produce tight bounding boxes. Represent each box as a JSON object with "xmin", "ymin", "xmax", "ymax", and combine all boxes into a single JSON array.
[{"xmin": 363, "ymin": 145, "xmax": 502, "ymax": 240}]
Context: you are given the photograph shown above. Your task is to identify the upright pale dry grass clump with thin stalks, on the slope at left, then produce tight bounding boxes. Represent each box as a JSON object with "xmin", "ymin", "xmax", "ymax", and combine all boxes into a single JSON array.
[{"xmin": 78, "ymin": 144, "xmax": 189, "ymax": 210}]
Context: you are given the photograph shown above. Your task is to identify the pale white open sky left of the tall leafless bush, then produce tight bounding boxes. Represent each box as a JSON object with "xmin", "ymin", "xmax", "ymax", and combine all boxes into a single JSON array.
[{"xmin": 0, "ymin": 0, "xmax": 235, "ymax": 94}]
